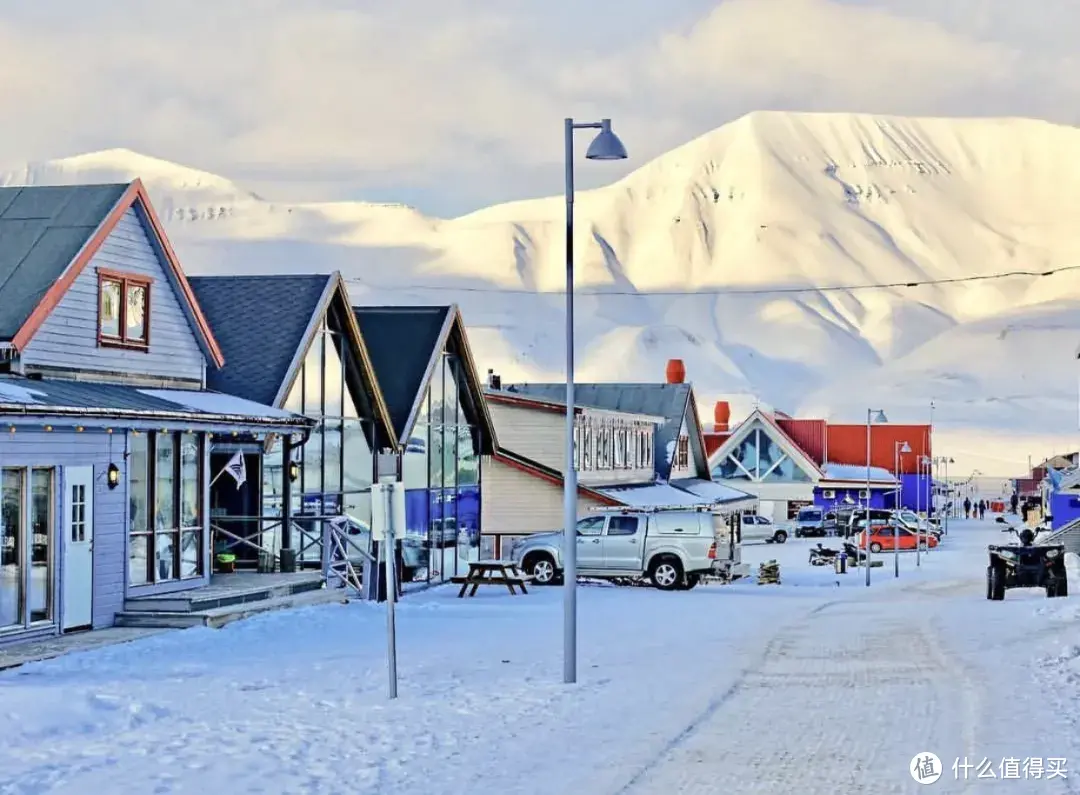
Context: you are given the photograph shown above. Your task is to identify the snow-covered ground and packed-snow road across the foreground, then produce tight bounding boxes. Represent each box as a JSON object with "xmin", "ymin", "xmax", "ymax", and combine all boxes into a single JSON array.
[{"xmin": 0, "ymin": 522, "xmax": 1080, "ymax": 795}]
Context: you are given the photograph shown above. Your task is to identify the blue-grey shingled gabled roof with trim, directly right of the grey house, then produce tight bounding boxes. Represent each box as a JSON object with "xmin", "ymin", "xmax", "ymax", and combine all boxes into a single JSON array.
[{"xmin": 191, "ymin": 273, "xmax": 395, "ymax": 446}]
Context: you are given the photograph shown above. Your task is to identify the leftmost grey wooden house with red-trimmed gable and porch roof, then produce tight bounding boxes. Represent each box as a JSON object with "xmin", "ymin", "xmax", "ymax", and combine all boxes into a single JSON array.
[{"xmin": 0, "ymin": 180, "xmax": 314, "ymax": 643}]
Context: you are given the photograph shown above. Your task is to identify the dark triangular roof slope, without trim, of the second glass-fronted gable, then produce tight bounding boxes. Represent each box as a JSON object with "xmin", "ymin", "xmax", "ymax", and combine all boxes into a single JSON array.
[{"xmin": 353, "ymin": 307, "xmax": 454, "ymax": 440}]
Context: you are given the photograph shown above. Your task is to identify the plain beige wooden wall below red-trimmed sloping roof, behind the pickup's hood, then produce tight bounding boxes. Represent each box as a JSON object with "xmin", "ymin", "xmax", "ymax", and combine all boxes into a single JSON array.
[{"xmin": 480, "ymin": 453, "xmax": 602, "ymax": 535}]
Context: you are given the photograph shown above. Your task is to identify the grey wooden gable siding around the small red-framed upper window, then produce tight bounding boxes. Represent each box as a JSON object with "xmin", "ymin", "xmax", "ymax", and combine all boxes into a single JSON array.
[{"xmin": 21, "ymin": 207, "xmax": 206, "ymax": 385}]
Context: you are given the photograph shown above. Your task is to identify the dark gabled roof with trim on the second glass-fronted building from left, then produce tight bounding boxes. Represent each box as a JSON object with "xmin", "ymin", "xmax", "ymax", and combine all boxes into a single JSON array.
[{"xmin": 353, "ymin": 305, "xmax": 497, "ymax": 455}]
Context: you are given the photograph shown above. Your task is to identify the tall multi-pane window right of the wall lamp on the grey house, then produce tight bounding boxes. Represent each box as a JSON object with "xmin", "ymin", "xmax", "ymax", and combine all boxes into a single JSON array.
[{"xmin": 127, "ymin": 433, "xmax": 206, "ymax": 585}]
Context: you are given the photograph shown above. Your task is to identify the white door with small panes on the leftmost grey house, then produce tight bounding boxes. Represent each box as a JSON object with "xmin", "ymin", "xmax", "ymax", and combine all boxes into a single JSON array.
[{"xmin": 60, "ymin": 467, "xmax": 94, "ymax": 630}]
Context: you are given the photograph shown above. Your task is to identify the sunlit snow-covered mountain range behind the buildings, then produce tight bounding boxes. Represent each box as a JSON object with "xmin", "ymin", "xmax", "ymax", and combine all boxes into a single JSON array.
[{"xmin": 8, "ymin": 112, "xmax": 1080, "ymax": 472}]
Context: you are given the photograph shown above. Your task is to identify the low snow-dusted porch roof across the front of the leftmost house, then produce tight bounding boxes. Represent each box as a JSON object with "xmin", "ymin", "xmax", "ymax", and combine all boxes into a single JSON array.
[{"xmin": 0, "ymin": 375, "xmax": 312, "ymax": 426}]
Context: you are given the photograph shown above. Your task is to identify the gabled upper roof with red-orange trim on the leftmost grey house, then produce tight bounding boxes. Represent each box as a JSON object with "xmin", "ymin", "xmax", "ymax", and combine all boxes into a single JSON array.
[{"xmin": 0, "ymin": 179, "xmax": 225, "ymax": 367}]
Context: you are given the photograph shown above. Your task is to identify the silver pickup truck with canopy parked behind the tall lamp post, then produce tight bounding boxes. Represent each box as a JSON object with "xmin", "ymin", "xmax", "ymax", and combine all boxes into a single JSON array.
[{"xmin": 510, "ymin": 507, "xmax": 748, "ymax": 591}]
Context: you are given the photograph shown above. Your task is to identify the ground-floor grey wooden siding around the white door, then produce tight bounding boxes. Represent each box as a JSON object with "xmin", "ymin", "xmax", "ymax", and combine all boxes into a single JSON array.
[{"xmin": 0, "ymin": 429, "xmax": 127, "ymax": 629}]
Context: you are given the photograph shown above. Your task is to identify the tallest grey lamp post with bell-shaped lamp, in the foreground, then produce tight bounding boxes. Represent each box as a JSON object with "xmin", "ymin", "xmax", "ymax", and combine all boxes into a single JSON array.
[{"xmin": 563, "ymin": 119, "xmax": 626, "ymax": 684}]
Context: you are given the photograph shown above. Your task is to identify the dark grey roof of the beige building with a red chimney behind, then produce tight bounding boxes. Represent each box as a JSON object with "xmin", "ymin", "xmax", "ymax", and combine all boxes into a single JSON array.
[{"xmin": 503, "ymin": 383, "xmax": 690, "ymax": 481}]
